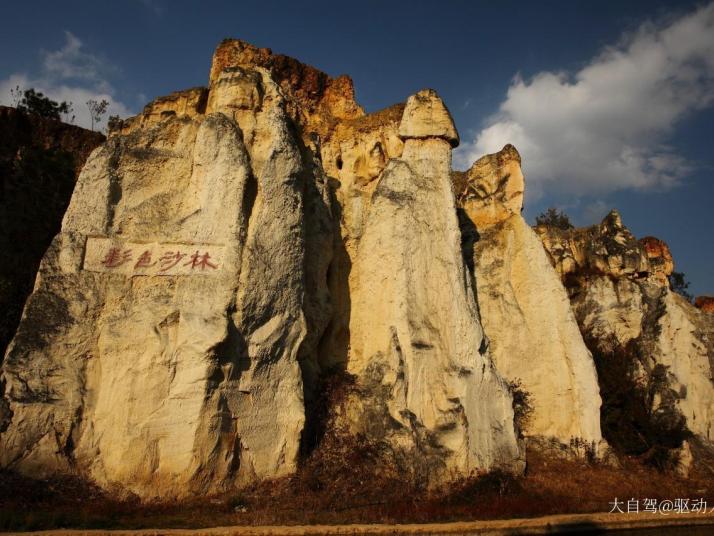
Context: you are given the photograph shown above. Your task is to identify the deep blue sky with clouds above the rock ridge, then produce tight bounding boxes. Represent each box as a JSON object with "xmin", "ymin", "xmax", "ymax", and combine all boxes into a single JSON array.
[{"xmin": 0, "ymin": 0, "xmax": 714, "ymax": 294}]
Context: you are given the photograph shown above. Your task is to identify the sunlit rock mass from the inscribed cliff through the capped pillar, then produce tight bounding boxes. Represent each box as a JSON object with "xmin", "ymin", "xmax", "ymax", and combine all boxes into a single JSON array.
[{"xmin": 0, "ymin": 41, "xmax": 522, "ymax": 498}]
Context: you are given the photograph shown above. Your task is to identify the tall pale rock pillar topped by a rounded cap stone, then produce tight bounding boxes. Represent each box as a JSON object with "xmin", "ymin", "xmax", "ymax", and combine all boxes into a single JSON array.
[{"xmin": 345, "ymin": 90, "xmax": 519, "ymax": 481}]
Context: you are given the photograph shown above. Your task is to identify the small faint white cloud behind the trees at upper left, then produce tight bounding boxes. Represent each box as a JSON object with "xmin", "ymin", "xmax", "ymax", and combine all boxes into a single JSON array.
[{"xmin": 0, "ymin": 32, "xmax": 133, "ymax": 129}]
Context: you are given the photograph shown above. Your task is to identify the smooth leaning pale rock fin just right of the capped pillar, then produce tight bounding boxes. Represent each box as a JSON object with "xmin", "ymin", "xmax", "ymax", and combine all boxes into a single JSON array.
[{"xmin": 455, "ymin": 145, "xmax": 602, "ymax": 448}]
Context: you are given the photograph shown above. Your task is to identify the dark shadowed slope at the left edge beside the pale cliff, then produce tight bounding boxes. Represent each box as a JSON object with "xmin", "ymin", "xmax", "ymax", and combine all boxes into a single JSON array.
[{"xmin": 0, "ymin": 106, "xmax": 104, "ymax": 363}]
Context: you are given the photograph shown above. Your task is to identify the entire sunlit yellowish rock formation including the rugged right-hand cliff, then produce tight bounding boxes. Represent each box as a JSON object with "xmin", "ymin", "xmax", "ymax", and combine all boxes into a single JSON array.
[{"xmin": 0, "ymin": 36, "xmax": 714, "ymax": 499}]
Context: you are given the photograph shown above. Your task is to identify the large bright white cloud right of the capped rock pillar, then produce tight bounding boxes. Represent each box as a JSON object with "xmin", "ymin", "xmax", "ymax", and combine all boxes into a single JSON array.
[{"xmin": 455, "ymin": 3, "xmax": 714, "ymax": 195}]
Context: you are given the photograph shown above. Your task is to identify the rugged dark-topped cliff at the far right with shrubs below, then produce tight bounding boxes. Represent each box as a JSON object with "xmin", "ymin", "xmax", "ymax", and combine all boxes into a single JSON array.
[{"xmin": 536, "ymin": 211, "xmax": 714, "ymax": 440}]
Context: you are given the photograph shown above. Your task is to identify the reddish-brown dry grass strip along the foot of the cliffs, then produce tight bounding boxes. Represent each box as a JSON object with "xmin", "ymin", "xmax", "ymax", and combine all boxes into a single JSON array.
[{"xmin": 0, "ymin": 444, "xmax": 714, "ymax": 530}]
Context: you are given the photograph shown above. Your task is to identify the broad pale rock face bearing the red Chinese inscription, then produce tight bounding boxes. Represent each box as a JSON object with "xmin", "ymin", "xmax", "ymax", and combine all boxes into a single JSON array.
[{"xmin": 0, "ymin": 68, "xmax": 334, "ymax": 498}]
